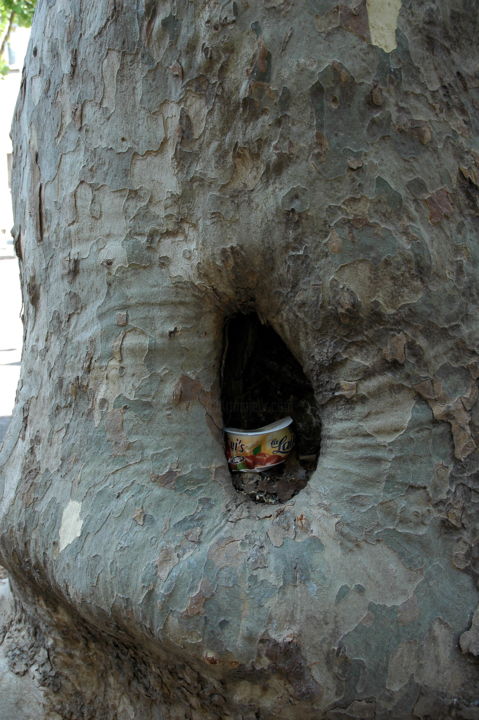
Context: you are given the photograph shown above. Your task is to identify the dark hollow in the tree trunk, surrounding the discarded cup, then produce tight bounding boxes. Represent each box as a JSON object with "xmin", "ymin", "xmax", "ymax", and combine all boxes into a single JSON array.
[{"xmin": 221, "ymin": 313, "xmax": 321, "ymax": 503}]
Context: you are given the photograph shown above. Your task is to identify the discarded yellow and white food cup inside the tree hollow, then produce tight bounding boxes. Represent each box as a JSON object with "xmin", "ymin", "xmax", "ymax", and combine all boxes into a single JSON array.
[{"xmin": 224, "ymin": 417, "xmax": 294, "ymax": 472}]
